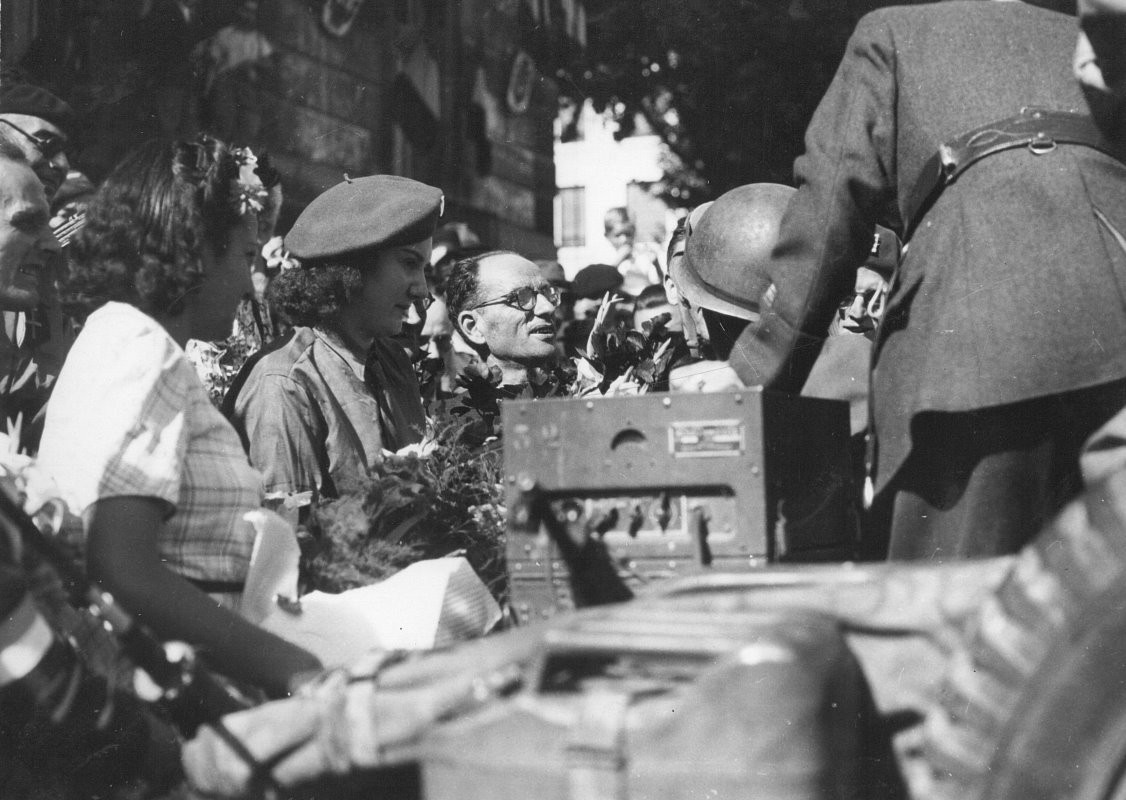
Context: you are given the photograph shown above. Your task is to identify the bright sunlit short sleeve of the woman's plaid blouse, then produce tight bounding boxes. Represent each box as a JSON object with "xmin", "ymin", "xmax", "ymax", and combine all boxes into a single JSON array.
[{"xmin": 39, "ymin": 313, "xmax": 194, "ymax": 514}]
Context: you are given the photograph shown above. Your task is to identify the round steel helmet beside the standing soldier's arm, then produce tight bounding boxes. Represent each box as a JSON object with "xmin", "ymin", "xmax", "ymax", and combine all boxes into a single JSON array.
[{"xmin": 669, "ymin": 184, "xmax": 795, "ymax": 321}]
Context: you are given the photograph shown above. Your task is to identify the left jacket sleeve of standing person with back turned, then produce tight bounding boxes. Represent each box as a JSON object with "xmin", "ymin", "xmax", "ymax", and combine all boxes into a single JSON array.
[{"xmin": 732, "ymin": 12, "xmax": 896, "ymax": 392}]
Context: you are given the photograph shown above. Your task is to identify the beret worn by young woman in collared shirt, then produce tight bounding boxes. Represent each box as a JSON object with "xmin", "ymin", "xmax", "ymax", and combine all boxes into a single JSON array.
[{"xmin": 285, "ymin": 175, "xmax": 443, "ymax": 263}]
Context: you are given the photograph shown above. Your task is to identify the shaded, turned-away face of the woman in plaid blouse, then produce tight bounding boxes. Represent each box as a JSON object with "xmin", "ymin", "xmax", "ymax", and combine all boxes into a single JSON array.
[{"xmin": 188, "ymin": 212, "xmax": 258, "ymax": 341}]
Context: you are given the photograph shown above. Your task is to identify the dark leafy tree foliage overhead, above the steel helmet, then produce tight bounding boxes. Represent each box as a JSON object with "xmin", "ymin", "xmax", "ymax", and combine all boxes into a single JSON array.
[{"xmin": 567, "ymin": 0, "xmax": 873, "ymax": 205}]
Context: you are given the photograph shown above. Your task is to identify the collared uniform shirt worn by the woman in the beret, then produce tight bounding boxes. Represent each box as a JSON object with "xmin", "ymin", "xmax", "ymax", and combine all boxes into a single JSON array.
[{"xmin": 231, "ymin": 328, "xmax": 426, "ymax": 499}]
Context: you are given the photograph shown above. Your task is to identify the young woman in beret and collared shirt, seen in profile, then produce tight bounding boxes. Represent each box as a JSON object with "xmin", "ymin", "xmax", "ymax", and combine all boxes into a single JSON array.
[{"xmin": 227, "ymin": 175, "xmax": 443, "ymax": 508}]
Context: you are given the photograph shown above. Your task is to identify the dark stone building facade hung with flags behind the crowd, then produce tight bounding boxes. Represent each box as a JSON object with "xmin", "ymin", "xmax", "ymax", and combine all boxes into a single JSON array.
[{"xmin": 0, "ymin": 0, "xmax": 586, "ymax": 258}]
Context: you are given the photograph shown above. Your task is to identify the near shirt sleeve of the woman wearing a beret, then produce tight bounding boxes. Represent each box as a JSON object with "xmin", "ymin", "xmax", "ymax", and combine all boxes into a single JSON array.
[{"xmin": 232, "ymin": 371, "xmax": 328, "ymax": 499}]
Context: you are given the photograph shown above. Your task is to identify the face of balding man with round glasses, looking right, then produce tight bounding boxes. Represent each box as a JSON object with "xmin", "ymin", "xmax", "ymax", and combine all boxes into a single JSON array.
[{"xmin": 458, "ymin": 254, "xmax": 557, "ymax": 365}]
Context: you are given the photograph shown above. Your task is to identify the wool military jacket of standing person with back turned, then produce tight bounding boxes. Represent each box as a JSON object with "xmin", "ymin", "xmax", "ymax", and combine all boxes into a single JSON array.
[{"xmin": 732, "ymin": 0, "xmax": 1126, "ymax": 489}]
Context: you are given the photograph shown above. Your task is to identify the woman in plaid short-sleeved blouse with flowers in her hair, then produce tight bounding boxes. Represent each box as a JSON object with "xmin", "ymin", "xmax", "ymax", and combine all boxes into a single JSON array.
[{"xmin": 39, "ymin": 137, "xmax": 320, "ymax": 696}]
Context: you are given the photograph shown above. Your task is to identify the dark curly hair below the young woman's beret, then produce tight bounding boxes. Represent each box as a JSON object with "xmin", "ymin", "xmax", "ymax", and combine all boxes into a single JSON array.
[{"xmin": 268, "ymin": 264, "xmax": 364, "ymax": 328}]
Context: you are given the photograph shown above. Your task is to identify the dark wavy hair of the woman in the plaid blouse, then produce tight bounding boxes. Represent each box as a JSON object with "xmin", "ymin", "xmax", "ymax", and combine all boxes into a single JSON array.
[{"xmin": 62, "ymin": 136, "xmax": 240, "ymax": 319}]
